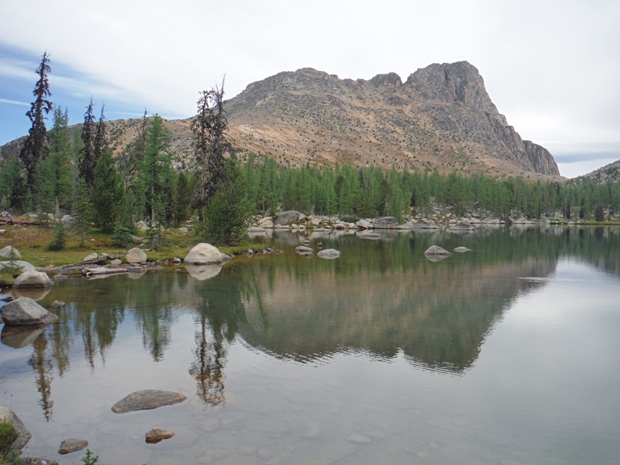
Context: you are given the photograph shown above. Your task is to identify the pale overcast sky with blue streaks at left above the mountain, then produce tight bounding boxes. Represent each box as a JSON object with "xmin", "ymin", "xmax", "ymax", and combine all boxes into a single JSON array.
[{"xmin": 0, "ymin": 0, "xmax": 620, "ymax": 177}]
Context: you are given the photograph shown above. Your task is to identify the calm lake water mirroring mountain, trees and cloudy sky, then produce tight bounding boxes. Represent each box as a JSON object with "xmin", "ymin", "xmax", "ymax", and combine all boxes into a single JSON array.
[{"xmin": 0, "ymin": 227, "xmax": 620, "ymax": 465}]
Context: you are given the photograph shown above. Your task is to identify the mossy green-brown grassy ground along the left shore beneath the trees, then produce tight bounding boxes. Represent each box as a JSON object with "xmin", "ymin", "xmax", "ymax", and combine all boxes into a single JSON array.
[{"xmin": 0, "ymin": 225, "xmax": 267, "ymax": 266}]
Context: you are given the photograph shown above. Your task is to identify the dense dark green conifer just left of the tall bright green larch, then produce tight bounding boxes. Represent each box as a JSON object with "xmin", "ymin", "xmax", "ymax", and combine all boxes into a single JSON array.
[{"xmin": 91, "ymin": 150, "xmax": 124, "ymax": 233}]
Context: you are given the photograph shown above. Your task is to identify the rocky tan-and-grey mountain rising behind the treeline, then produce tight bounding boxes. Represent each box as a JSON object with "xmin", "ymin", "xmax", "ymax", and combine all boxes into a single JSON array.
[{"xmin": 0, "ymin": 61, "xmax": 559, "ymax": 179}]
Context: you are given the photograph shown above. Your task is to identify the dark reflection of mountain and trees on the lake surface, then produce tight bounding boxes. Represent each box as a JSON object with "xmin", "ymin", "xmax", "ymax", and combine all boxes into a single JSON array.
[{"xmin": 0, "ymin": 227, "xmax": 620, "ymax": 421}]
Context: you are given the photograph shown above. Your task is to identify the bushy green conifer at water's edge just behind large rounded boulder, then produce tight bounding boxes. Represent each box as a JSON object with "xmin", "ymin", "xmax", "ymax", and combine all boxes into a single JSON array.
[{"xmin": 199, "ymin": 158, "xmax": 250, "ymax": 245}]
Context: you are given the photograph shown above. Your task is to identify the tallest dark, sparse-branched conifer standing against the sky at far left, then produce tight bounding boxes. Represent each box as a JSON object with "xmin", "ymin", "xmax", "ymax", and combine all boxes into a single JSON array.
[{"xmin": 19, "ymin": 52, "xmax": 52, "ymax": 190}]
